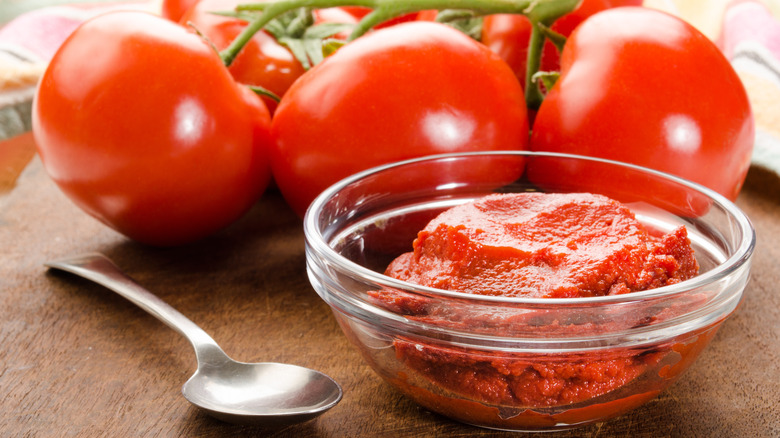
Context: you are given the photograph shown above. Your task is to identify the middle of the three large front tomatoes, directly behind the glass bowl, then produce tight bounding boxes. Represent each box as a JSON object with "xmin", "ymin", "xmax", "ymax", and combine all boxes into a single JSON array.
[{"xmin": 271, "ymin": 21, "xmax": 528, "ymax": 215}]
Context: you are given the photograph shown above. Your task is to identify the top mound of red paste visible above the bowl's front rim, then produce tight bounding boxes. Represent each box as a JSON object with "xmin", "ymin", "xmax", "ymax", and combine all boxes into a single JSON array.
[{"xmin": 386, "ymin": 193, "xmax": 699, "ymax": 298}]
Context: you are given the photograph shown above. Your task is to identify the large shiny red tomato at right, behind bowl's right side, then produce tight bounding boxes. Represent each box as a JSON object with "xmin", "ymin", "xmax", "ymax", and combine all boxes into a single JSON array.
[{"xmin": 531, "ymin": 8, "xmax": 754, "ymax": 202}]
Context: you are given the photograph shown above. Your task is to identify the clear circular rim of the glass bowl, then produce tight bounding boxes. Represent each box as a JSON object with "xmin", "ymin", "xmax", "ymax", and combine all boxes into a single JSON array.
[{"xmin": 303, "ymin": 150, "xmax": 756, "ymax": 307}]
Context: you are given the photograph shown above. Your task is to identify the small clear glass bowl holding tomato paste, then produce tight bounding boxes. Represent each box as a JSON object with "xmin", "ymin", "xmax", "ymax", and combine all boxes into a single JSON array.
[{"xmin": 304, "ymin": 152, "xmax": 755, "ymax": 431}]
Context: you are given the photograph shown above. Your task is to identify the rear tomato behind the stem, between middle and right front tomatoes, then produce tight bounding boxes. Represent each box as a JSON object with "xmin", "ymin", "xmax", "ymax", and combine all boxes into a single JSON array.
[{"xmin": 482, "ymin": 0, "xmax": 642, "ymax": 84}]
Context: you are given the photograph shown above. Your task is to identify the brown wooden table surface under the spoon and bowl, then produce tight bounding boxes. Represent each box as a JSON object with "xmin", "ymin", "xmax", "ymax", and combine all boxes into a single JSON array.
[{"xmin": 0, "ymin": 134, "xmax": 780, "ymax": 438}]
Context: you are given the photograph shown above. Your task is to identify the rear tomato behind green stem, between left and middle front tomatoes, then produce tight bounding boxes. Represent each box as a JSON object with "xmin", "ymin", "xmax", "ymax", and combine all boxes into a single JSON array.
[{"xmin": 181, "ymin": 0, "xmax": 357, "ymax": 114}]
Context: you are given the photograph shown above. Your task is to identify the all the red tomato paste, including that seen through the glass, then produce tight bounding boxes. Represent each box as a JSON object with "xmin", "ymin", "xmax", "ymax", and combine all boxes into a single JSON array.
[{"xmin": 373, "ymin": 193, "xmax": 699, "ymax": 416}]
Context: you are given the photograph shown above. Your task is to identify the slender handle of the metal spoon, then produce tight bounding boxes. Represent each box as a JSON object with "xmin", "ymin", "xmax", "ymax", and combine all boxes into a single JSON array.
[{"xmin": 44, "ymin": 253, "xmax": 227, "ymax": 363}]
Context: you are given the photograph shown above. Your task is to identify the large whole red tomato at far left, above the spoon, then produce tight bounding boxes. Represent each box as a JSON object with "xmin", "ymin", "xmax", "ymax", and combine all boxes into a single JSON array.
[{"xmin": 33, "ymin": 12, "xmax": 270, "ymax": 246}]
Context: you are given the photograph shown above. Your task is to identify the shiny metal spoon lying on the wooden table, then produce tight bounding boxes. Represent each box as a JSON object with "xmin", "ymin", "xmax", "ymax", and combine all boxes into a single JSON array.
[{"xmin": 45, "ymin": 254, "xmax": 342, "ymax": 427}]
